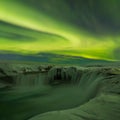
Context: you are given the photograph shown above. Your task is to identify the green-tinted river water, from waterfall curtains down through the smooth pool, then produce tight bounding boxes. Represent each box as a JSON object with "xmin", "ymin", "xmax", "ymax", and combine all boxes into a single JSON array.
[{"xmin": 0, "ymin": 69, "xmax": 109, "ymax": 120}]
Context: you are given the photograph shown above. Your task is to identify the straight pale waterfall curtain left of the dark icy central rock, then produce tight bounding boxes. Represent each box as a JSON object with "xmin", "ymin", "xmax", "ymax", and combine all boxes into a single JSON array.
[{"xmin": 15, "ymin": 73, "xmax": 46, "ymax": 90}]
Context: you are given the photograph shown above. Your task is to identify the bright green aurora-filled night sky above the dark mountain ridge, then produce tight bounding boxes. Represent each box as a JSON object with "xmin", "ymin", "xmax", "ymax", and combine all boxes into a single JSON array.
[{"xmin": 0, "ymin": 0, "xmax": 120, "ymax": 61}]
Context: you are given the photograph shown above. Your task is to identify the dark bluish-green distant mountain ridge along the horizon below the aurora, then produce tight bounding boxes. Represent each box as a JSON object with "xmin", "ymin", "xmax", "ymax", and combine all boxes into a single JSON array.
[{"xmin": 0, "ymin": 53, "xmax": 119, "ymax": 65}]
